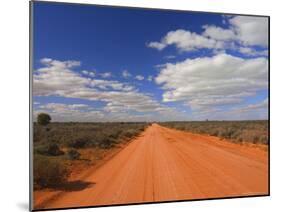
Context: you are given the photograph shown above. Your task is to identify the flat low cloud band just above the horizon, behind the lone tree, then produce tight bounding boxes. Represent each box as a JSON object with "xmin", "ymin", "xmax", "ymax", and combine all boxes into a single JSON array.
[{"xmin": 33, "ymin": 102, "xmax": 186, "ymax": 122}]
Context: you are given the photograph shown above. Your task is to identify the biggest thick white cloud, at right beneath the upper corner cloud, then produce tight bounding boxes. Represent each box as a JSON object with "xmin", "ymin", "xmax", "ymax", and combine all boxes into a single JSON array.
[{"xmin": 155, "ymin": 54, "xmax": 268, "ymax": 110}]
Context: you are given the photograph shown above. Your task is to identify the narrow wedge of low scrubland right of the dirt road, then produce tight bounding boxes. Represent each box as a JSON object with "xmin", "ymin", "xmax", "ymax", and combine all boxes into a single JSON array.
[{"xmin": 161, "ymin": 120, "xmax": 268, "ymax": 145}]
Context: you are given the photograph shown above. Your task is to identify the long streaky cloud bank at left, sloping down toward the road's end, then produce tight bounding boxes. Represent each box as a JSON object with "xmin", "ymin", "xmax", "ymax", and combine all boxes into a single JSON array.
[{"xmin": 33, "ymin": 59, "xmax": 175, "ymax": 120}]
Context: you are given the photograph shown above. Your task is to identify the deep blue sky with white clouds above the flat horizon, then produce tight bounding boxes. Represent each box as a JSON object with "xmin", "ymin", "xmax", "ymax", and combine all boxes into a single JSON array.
[{"xmin": 33, "ymin": 2, "xmax": 268, "ymax": 121}]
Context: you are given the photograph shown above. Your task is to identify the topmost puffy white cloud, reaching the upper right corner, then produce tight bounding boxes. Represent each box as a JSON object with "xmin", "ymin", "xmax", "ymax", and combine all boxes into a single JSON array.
[{"xmin": 147, "ymin": 16, "xmax": 268, "ymax": 51}]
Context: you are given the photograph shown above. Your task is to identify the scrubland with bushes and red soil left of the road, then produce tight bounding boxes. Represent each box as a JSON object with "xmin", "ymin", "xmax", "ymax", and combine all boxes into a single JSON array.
[{"xmin": 33, "ymin": 116, "xmax": 147, "ymax": 189}]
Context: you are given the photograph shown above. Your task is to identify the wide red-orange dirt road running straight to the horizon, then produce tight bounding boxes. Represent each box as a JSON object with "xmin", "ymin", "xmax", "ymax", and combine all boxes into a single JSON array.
[{"xmin": 37, "ymin": 124, "xmax": 268, "ymax": 208}]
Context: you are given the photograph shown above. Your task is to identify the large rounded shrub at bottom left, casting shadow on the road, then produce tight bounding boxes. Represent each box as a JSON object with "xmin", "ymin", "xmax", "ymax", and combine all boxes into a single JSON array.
[{"xmin": 33, "ymin": 156, "xmax": 70, "ymax": 188}]
